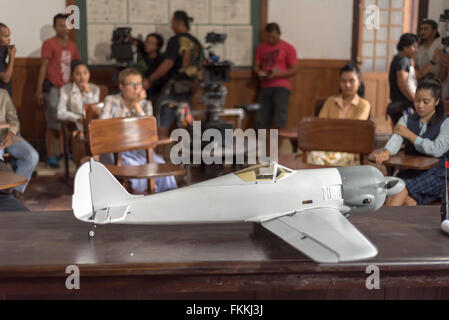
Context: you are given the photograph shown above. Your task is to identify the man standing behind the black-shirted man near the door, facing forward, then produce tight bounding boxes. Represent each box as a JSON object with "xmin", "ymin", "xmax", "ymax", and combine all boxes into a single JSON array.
[{"xmin": 415, "ymin": 19, "xmax": 442, "ymax": 80}]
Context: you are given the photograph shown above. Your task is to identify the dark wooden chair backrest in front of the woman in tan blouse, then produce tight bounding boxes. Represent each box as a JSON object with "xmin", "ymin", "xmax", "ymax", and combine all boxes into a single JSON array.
[{"xmin": 298, "ymin": 117, "xmax": 375, "ymax": 164}]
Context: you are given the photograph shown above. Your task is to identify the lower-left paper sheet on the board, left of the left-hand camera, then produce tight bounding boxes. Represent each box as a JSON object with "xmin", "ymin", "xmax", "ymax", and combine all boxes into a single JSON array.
[{"xmin": 87, "ymin": 24, "xmax": 114, "ymax": 64}]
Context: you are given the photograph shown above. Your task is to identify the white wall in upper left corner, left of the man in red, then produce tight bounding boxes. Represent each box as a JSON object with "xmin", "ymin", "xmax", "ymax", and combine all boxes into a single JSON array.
[{"xmin": 0, "ymin": 0, "xmax": 65, "ymax": 57}]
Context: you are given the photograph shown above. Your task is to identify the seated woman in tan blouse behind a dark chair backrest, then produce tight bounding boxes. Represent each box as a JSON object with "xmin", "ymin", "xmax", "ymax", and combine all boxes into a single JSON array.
[{"xmin": 307, "ymin": 63, "xmax": 371, "ymax": 166}]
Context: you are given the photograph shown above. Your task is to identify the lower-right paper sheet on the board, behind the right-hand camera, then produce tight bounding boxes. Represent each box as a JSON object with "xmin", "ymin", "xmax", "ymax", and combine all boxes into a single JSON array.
[{"xmin": 225, "ymin": 26, "xmax": 253, "ymax": 66}]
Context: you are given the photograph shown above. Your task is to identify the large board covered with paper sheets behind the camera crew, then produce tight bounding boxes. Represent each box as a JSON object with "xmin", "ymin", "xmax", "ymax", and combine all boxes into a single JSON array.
[{"xmin": 86, "ymin": 0, "xmax": 253, "ymax": 67}]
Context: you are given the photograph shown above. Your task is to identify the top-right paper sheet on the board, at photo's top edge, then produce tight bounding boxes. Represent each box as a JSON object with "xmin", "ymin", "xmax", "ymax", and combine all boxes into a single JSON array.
[{"xmin": 211, "ymin": 0, "xmax": 251, "ymax": 24}]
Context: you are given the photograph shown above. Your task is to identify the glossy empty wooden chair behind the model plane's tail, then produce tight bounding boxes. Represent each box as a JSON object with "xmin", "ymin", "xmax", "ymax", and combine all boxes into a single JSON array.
[{"xmin": 89, "ymin": 116, "xmax": 186, "ymax": 193}]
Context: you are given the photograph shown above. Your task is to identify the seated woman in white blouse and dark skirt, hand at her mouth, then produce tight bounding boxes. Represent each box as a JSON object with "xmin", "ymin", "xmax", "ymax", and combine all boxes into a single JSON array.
[{"xmin": 57, "ymin": 60, "xmax": 100, "ymax": 166}]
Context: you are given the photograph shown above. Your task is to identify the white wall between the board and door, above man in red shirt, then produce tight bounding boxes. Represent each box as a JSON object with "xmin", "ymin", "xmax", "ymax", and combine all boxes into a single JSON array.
[{"xmin": 268, "ymin": 0, "xmax": 353, "ymax": 60}]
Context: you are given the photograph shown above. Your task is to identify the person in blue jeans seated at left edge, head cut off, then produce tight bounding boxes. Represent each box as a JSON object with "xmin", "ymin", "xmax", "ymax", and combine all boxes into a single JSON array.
[{"xmin": 0, "ymin": 89, "xmax": 39, "ymax": 198}]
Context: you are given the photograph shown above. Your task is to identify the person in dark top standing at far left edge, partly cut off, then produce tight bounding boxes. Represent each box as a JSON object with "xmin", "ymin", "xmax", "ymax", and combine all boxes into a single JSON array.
[{"xmin": 0, "ymin": 23, "xmax": 16, "ymax": 97}]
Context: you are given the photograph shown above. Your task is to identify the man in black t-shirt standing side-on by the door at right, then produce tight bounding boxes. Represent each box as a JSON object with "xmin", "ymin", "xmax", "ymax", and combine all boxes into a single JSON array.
[{"xmin": 387, "ymin": 33, "xmax": 419, "ymax": 125}]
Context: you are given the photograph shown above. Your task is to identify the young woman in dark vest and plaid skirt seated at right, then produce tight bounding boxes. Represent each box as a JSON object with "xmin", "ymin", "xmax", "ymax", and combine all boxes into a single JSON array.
[{"xmin": 376, "ymin": 79, "xmax": 449, "ymax": 206}]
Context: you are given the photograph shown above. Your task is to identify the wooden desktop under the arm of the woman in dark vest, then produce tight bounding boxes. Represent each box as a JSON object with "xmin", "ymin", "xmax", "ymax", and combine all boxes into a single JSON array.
[{"xmin": 369, "ymin": 149, "xmax": 439, "ymax": 170}]
